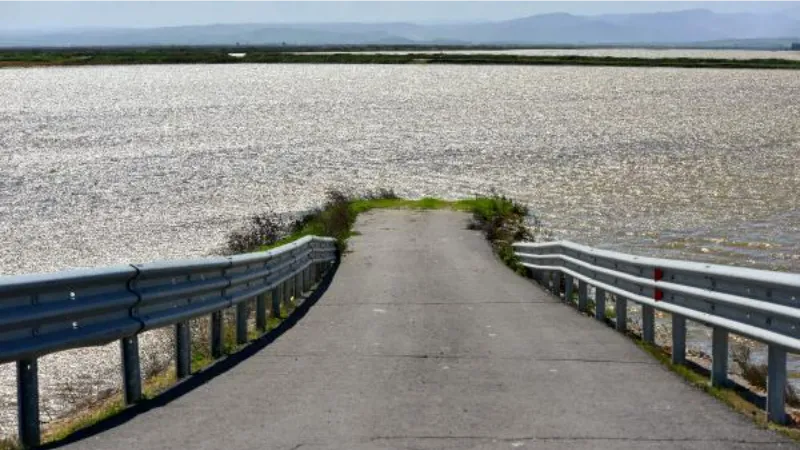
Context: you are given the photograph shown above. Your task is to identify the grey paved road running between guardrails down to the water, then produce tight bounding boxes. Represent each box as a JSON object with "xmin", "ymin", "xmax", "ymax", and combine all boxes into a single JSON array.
[{"xmin": 68, "ymin": 211, "xmax": 793, "ymax": 450}]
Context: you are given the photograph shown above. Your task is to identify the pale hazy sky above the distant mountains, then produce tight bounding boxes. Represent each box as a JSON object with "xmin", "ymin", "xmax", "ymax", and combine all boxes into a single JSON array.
[{"xmin": 0, "ymin": 0, "xmax": 798, "ymax": 31}]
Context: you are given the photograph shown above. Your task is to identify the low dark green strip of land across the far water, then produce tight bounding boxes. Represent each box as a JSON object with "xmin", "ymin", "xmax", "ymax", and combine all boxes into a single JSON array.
[{"xmin": 0, "ymin": 47, "xmax": 800, "ymax": 70}]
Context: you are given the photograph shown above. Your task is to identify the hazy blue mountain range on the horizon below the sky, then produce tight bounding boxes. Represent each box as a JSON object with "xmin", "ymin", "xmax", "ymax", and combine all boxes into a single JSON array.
[{"xmin": 0, "ymin": 8, "xmax": 800, "ymax": 47}]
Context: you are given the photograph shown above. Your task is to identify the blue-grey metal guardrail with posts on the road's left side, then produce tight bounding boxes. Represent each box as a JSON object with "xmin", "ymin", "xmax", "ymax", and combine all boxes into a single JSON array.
[{"xmin": 0, "ymin": 237, "xmax": 337, "ymax": 447}]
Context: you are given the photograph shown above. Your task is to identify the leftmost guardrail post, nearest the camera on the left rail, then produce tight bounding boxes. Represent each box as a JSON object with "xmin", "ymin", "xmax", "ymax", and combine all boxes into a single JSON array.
[{"xmin": 17, "ymin": 359, "xmax": 41, "ymax": 448}]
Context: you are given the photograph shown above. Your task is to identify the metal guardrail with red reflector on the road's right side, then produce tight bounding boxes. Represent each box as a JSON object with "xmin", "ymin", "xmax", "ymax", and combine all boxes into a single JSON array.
[{"xmin": 514, "ymin": 242, "xmax": 800, "ymax": 423}]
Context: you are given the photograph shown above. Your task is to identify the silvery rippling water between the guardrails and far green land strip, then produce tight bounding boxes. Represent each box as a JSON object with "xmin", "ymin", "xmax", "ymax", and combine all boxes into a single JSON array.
[{"xmin": 0, "ymin": 65, "xmax": 800, "ymax": 274}]
